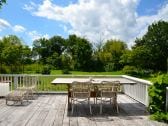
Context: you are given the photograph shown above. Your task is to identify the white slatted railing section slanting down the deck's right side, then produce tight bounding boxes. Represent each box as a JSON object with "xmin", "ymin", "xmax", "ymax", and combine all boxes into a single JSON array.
[{"xmin": 122, "ymin": 75, "xmax": 152, "ymax": 106}]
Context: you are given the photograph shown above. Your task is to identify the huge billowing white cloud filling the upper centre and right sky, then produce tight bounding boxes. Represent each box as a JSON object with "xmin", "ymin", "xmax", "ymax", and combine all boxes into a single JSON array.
[{"xmin": 23, "ymin": 0, "xmax": 168, "ymax": 45}]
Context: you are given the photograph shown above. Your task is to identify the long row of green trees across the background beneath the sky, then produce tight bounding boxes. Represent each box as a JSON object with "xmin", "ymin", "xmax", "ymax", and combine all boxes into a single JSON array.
[{"xmin": 0, "ymin": 21, "xmax": 168, "ymax": 75}]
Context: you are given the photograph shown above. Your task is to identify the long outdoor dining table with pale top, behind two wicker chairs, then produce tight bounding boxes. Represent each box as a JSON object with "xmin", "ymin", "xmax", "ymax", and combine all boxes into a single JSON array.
[{"xmin": 51, "ymin": 77, "xmax": 136, "ymax": 109}]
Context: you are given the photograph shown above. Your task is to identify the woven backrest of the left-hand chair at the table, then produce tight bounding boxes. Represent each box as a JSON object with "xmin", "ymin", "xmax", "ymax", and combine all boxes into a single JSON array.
[{"xmin": 71, "ymin": 81, "xmax": 91, "ymax": 98}]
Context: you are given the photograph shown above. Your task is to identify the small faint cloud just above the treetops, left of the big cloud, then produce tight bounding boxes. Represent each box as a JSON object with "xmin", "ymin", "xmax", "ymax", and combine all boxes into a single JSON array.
[{"xmin": 27, "ymin": 31, "xmax": 49, "ymax": 41}]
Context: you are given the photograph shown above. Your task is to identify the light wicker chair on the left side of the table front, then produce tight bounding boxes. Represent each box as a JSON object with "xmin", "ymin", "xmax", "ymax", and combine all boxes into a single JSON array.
[{"xmin": 70, "ymin": 81, "xmax": 92, "ymax": 114}]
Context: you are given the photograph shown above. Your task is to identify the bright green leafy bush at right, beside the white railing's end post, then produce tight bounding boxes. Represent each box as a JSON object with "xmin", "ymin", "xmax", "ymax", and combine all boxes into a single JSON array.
[{"xmin": 148, "ymin": 74, "xmax": 168, "ymax": 122}]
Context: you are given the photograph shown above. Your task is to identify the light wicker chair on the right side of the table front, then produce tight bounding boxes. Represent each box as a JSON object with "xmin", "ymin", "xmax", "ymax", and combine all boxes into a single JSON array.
[{"xmin": 99, "ymin": 81, "xmax": 120, "ymax": 114}]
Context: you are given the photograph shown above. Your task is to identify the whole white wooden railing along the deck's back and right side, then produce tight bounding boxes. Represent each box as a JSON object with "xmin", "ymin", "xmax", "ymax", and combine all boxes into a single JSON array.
[{"xmin": 0, "ymin": 74, "xmax": 151, "ymax": 106}]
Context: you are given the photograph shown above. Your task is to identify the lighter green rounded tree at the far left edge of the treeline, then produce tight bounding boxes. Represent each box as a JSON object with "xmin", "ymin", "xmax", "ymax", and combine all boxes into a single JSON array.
[{"xmin": 0, "ymin": 35, "xmax": 32, "ymax": 73}]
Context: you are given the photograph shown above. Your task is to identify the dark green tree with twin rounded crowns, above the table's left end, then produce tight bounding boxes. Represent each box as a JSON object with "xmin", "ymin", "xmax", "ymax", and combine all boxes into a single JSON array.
[{"xmin": 33, "ymin": 36, "xmax": 65, "ymax": 69}]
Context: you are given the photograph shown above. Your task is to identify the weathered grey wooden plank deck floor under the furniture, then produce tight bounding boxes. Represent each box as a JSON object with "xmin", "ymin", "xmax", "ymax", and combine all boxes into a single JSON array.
[{"xmin": 0, "ymin": 94, "xmax": 166, "ymax": 126}]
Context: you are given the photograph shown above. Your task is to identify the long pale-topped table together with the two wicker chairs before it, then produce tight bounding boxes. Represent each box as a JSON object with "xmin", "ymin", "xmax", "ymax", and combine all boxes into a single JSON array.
[{"xmin": 51, "ymin": 77, "xmax": 136, "ymax": 114}]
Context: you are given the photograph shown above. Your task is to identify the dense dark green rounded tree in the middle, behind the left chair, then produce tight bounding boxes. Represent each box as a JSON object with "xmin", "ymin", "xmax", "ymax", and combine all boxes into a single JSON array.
[{"xmin": 67, "ymin": 35, "xmax": 92, "ymax": 71}]
